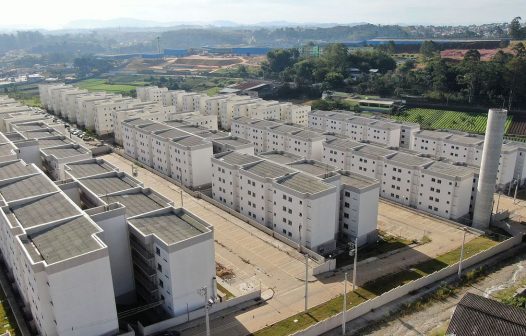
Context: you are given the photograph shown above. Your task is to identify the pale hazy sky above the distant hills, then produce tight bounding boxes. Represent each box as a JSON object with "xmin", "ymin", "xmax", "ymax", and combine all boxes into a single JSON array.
[{"xmin": 0, "ymin": 0, "xmax": 526, "ymax": 29}]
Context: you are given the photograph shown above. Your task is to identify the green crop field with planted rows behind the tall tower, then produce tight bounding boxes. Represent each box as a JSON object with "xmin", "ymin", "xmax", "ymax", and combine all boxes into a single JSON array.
[{"xmin": 390, "ymin": 108, "xmax": 513, "ymax": 134}]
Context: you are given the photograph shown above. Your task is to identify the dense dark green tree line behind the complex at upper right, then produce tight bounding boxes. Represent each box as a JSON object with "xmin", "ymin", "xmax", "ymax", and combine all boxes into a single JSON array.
[{"xmin": 262, "ymin": 42, "xmax": 526, "ymax": 109}]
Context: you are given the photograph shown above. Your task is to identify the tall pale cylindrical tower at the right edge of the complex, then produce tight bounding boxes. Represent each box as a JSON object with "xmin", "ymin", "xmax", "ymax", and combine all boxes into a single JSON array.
[{"xmin": 473, "ymin": 109, "xmax": 508, "ymax": 229}]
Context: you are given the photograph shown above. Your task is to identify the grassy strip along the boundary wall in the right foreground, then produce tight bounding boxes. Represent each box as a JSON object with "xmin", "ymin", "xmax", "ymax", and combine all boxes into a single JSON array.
[{"xmin": 254, "ymin": 237, "xmax": 497, "ymax": 336}]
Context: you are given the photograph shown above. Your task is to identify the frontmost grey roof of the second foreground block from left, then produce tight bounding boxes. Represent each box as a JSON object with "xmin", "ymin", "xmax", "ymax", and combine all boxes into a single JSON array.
[{"xmin": 129, "ymin": 211, "xmax": 209, "ymax": 245}]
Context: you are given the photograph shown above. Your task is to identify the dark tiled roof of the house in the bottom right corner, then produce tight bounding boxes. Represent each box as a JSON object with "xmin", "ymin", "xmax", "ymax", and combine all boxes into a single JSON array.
[{"xmin": 446, "ymin": 293, "xmax": 526, "ymax": 336}]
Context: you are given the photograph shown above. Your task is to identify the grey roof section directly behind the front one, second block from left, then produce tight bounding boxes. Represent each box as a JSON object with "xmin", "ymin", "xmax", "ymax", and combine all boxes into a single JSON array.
[{"xmin": 101, "ymin": 191, "xmax": 169, "ymax": 217}]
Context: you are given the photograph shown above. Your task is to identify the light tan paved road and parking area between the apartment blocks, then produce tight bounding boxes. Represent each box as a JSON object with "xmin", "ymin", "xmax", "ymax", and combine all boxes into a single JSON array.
[{"xmin": 101, "ymin": 154, "xmax": 480, "ymax": 336}]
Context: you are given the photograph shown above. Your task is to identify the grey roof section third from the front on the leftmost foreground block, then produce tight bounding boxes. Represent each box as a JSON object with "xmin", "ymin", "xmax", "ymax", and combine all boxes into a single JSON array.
[{"xmin": 0, "ymin": 175, "xmax": 57, "ymax": 202}]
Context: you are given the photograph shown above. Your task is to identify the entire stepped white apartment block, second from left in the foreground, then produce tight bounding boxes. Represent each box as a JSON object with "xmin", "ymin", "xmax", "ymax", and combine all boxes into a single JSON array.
[{"xmin": 64, "ymin": 159, "xmax": 216, "ymax": 316}]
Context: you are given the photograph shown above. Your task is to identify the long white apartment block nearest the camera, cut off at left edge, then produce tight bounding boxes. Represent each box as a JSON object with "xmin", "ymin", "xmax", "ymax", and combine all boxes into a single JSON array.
[{"xmin": 0, "ymin": 161, "xmax": 119, "ymax": 335}]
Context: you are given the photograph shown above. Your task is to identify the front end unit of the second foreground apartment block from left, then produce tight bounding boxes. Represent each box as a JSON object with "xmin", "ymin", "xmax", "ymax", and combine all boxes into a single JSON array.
[{"xmin": 128, "ymin": 208, "xmax": 216, "ymax": 316}]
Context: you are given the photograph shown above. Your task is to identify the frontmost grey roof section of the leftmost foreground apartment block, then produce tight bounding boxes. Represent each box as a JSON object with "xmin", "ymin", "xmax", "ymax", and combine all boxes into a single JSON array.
[{"xmin": 28, "ymin": 216, "xmax": 102, "ymax": 264}]
